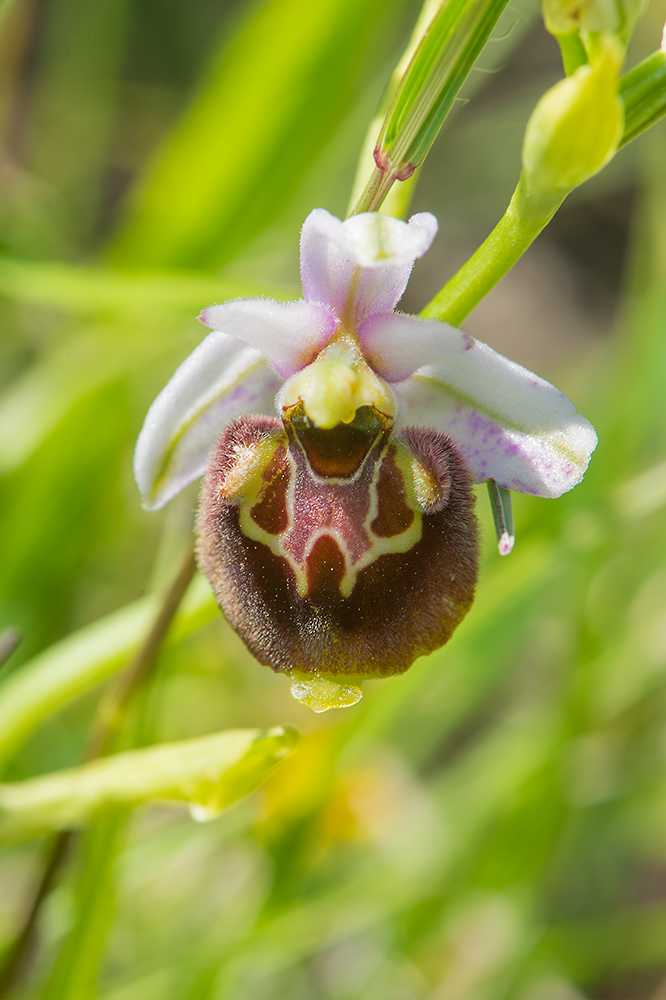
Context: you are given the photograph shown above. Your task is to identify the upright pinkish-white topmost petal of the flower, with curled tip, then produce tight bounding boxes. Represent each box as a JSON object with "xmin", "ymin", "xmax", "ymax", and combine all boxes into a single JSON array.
[{"xmin": 301, "ymin": 208, "xmax": 437, "ymax": 322}]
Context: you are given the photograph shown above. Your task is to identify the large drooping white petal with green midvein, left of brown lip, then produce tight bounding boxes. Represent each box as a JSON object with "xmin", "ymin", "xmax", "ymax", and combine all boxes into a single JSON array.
[{"xmin": 134, "ymin": 332, "xmax": 282, "ymax": 510}]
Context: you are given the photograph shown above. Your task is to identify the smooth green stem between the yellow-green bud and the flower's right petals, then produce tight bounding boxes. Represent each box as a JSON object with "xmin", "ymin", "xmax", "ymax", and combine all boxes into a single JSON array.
[{"xmin": 421, "ymin": 176, "xmax": 566, "ymax": 326}]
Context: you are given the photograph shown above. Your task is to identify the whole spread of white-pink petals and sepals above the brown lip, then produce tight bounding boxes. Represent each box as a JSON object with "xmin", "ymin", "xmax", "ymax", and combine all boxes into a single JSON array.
[{"xmin": 135, "ymin": 209, "xmax": 596, "ymax": 510}]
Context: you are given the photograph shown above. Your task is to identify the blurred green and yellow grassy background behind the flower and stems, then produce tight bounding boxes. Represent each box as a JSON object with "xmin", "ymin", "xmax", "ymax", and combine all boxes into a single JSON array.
[{"xmin": 0, "ymin": 0, "xmax": 666, "ymax": 1000}]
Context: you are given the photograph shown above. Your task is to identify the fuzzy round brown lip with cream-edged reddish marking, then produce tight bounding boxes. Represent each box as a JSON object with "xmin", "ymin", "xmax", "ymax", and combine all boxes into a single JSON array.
[{"xmin": 198, "ymin": 394, "xmax": 477, "ymax": 703}]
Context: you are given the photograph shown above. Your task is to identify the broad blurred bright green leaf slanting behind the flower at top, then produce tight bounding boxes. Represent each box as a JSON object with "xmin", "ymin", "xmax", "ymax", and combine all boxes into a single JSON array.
[{"xmin": 108, "ymin": 0, "xmax": 391, "ymax": 267}]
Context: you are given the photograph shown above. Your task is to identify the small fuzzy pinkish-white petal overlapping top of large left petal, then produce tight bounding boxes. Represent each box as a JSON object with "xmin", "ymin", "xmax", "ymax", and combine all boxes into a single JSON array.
[{"xmin": 199, "ymin": 299, "xmax": 336, "ymax": 378}]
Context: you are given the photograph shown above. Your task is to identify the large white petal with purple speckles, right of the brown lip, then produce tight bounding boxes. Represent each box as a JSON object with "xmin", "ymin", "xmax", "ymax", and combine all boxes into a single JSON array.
[{"xmin": 393, "ymin": 328, "xmax": 597, "ymax": 497}]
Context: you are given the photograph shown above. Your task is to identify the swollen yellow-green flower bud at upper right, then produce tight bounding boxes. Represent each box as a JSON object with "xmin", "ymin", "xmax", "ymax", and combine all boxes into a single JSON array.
[{"xmin": 523, "ymin": 40, "xmax": 623, "ymax": 198}]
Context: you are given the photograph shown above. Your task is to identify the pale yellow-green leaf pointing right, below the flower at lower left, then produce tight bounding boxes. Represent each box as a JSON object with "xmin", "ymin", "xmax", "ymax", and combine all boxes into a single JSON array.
[{"xmin": 0, "ymin": 726, "xmax": 298, "ymax": 840}]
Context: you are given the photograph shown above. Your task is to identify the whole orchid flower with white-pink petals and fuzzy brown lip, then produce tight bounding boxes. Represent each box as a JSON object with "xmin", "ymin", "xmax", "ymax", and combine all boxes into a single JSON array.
[{"xmin": 135, "ymin": 209, "xmax": 596, "ymax": 710}]
